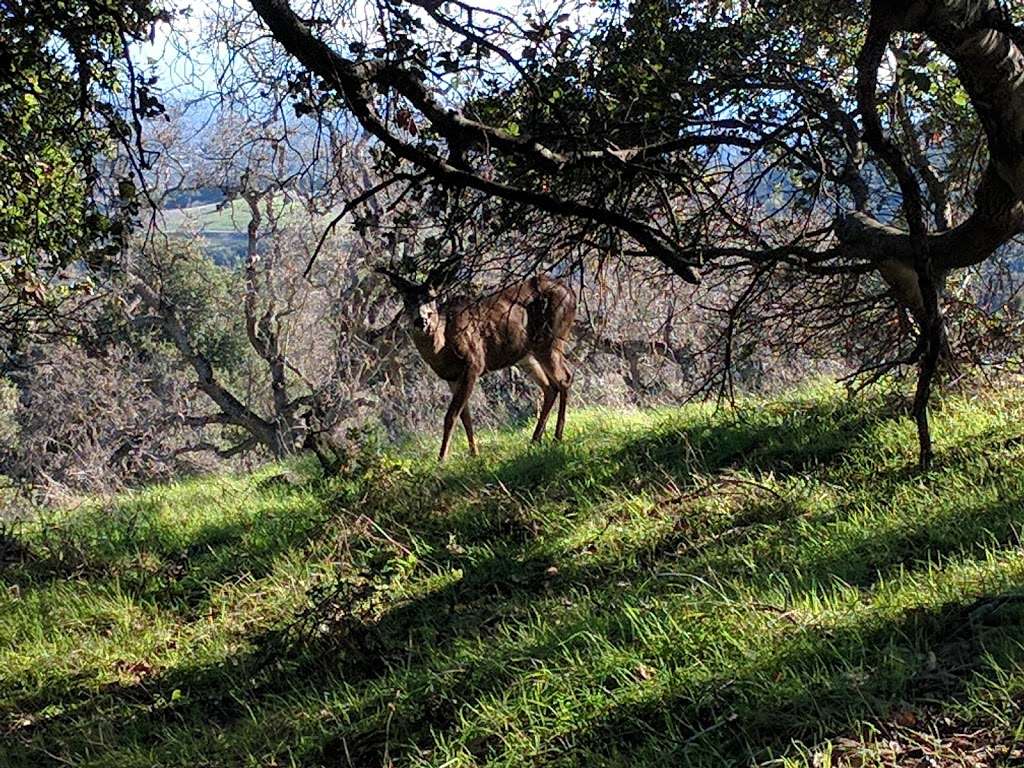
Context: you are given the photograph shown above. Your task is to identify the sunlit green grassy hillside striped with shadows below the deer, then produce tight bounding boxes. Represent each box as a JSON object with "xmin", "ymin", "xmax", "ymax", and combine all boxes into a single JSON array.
[{"xmin": 0, "ymin": 389, "xmax": 1024, "ymax": 768}]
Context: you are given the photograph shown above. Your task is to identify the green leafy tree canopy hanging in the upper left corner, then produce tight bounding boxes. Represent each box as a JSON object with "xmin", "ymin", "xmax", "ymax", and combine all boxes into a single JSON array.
[{"xmin": 0, "ymin": 0, "xmax": 163, "ymax": 348}]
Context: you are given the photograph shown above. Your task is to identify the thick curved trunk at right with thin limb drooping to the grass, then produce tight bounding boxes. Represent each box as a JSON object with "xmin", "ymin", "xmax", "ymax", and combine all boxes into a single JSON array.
[{"xmin": 857, "ymin": 0, "xmax": 1024, "ymax": 469}]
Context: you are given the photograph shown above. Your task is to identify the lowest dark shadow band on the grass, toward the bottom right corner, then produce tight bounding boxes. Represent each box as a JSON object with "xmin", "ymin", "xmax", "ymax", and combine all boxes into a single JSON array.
[{"xmin": 556, "ymin": 584, "xmax": 1024, "ymax": 766}]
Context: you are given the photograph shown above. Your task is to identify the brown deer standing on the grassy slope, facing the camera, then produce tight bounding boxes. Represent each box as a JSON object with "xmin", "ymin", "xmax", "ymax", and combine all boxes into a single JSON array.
[{"xmin": 378, "ymin": 268, "xmax": 577, "ymax": 462}]
